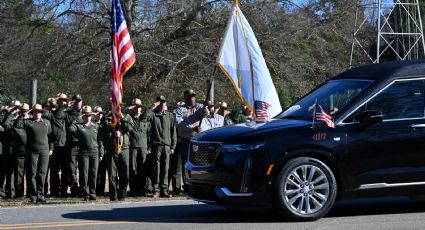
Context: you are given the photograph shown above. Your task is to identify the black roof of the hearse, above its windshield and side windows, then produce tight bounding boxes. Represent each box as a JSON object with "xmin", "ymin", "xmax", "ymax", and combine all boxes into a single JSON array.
[{"xmin": 332, "ymin": 60, "xmax": 425, "ymax": 81}]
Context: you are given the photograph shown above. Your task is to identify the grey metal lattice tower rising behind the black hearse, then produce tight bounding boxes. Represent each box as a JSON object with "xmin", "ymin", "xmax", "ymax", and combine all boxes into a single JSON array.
[{"xmin": 350, "ymin": 0, "xmax": 425, "ymax": 67}]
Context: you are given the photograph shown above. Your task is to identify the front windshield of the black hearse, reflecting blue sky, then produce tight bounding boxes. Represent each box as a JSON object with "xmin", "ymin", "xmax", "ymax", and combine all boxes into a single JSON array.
[{"xmin": 278, "ymin": 80, "xmax": 371, "ymax": 120}]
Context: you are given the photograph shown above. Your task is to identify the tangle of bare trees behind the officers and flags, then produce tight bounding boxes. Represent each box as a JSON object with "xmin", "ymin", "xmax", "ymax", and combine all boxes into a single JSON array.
[{"xmin": 0, "ymin": 0, "xmax": 355, "ymax": 108}]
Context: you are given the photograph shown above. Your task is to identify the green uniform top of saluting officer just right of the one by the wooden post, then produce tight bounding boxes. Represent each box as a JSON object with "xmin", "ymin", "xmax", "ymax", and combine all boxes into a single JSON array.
[{"xmin": 43, "ymin": 107, "xmax": 67, "ymax": 146}]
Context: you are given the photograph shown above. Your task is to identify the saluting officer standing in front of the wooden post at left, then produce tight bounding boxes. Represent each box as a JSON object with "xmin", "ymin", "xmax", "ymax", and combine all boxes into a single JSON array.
[{"xmin": 17, "ymin": 104, "xmax": 53, "ymax": 203}]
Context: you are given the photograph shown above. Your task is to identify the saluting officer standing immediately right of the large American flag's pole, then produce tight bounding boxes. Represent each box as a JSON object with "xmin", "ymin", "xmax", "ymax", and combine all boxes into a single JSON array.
[{"xmin": 123, "ymin": 98, "xmax": 151, "ymax": 196}]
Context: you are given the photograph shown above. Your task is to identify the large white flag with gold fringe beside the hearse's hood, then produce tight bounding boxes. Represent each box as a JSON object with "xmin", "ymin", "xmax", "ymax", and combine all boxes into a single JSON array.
[{"xmin": 216, "ymin": 4, "xmax": 282, "ymax": 118}]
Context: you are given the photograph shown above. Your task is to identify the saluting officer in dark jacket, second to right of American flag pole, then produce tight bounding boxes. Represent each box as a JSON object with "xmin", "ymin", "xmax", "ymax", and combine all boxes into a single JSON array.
[{"xmin": 149, "ymin": 96, "xmax": 177, "ymax": 198}]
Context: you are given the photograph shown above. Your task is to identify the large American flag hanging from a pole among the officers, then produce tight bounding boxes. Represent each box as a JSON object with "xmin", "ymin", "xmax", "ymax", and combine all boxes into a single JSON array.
[{"xmin": 111, "ymin": 0, "xmax": 136, "ymax": 126}]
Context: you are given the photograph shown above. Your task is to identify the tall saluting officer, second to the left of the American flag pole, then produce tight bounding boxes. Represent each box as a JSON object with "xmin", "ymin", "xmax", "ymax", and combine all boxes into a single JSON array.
[{"xmin": 66, "ymin": 94, "xmax": 83, "ymax": 197}]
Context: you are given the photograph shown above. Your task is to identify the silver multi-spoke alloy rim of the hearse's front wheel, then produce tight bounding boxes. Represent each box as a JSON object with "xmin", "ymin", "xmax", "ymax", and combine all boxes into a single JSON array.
[{"xmin": 283, "ymin": 165, "xmax": 330, "ymax": 215}]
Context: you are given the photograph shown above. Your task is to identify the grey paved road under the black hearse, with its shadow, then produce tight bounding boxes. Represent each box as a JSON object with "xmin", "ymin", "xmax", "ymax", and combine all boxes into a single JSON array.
[{"xmin": 0, "ymin": 198, "xmax": 425, "ymax": 230}]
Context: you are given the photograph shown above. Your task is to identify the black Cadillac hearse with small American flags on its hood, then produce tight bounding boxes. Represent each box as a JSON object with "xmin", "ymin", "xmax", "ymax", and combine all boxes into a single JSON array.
[{"xmin": 185, "ymin": 61, "xmax": 425, "ymax": 221}]
